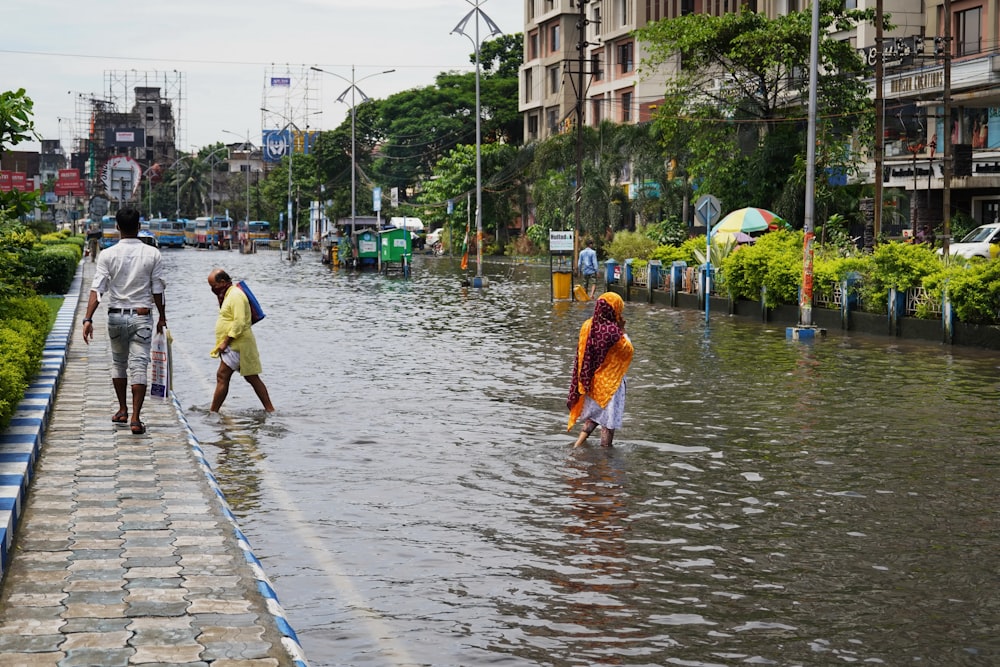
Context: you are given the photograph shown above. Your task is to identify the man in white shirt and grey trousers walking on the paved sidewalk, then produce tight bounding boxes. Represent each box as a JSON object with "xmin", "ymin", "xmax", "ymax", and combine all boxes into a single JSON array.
[{"xmin": 83, "ymin": 208, "xmax": 167, "ymax": 435}]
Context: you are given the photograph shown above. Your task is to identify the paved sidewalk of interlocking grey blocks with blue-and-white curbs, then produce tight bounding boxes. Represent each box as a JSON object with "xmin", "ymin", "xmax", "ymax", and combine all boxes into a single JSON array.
[{"xmin": 0, "ymin": 262, "xmax": 307, "ymax": 667}]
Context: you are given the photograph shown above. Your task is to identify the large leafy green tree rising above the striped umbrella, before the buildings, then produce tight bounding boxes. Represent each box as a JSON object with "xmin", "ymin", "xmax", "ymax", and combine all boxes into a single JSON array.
[{"xmin": 637, "ymin": 0, "xmax": 890, "ymax": 227}]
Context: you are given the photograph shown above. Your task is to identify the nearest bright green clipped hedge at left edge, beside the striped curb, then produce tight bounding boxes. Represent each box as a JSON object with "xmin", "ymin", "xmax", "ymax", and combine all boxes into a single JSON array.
[{"xmin": 0, "ymin": 296, "xmax": 49, "ymax": 430}]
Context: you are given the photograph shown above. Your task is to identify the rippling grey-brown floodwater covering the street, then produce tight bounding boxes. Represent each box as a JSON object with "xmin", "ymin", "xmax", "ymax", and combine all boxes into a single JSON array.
[{"xmin": 164, "ymin": 249, "xmax": 1000, "ymax": 667}]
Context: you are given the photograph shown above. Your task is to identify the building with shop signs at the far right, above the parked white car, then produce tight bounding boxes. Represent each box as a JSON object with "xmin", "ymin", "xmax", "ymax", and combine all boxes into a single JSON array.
[{"xmin": 865, "ymin": 0, "xmax": 1000, "ymax": 231}]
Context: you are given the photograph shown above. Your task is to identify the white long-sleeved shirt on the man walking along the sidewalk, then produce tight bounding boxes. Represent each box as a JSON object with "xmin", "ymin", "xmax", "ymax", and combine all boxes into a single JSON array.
[{"xmin": 90, "ymin": 239, "xmax": 166, "ymax": 308}]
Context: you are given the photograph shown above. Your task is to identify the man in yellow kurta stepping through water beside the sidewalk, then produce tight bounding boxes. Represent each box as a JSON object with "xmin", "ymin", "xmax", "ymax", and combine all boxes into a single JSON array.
[{"xmin": 208, "ymin": 269, "xmax": 274, "ymax": 412}]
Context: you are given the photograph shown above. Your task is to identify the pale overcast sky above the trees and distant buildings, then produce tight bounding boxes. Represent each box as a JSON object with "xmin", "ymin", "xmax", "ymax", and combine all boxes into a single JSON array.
[{"xmin": 0, "ymin": 0, "xmax": 524, "ymax": 155}]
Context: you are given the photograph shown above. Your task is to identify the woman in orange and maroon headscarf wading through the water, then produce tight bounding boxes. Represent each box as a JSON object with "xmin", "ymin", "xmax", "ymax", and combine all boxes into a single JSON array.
[{"xmin": 566, "ymin": 292, "xmax": 634, "ymax": 447}]
